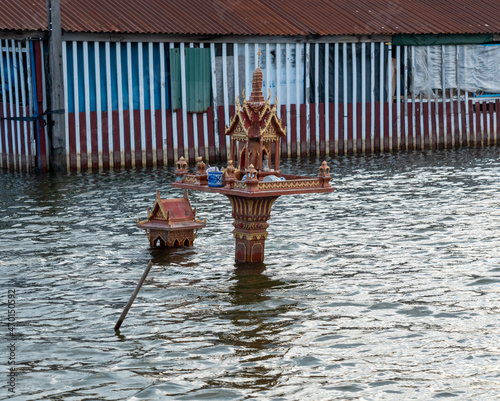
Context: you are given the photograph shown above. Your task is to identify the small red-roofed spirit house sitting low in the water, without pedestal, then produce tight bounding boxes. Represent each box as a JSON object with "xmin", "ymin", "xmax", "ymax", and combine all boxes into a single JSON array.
[{"xmin": 137, "ymin": 191, "xmax": 207, "ymax": 248}]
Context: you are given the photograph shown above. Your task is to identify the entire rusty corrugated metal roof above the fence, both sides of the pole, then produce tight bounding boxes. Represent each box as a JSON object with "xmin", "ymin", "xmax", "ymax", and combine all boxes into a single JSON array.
[{"xmin": 0, "ymin": 0, "xmax": 500, "ymax": 36}]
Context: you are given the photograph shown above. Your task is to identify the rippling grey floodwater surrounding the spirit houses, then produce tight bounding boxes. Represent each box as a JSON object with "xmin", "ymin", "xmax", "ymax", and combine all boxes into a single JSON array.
[{"xmin": 0, "ymin": 148, "xmax": 500, "ymax": 400}]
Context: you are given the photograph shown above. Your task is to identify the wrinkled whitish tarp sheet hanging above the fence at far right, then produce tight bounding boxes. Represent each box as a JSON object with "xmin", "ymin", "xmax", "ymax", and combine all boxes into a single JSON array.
[{"xmin": 413, "ymin": 45, "xmax": 500, "ymax": 96}]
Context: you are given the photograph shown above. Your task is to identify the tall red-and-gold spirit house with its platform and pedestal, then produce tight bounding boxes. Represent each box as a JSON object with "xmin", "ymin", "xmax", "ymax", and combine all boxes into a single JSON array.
[{"xmin": 172, "ymin": 53, "xmax": 334, "ymax": 263}]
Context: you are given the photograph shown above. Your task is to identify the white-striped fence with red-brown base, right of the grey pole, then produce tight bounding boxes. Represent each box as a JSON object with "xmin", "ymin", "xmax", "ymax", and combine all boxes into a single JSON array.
[{"xmin": 2, "ymin": 41, "xmax": 500, "ymax": 170}]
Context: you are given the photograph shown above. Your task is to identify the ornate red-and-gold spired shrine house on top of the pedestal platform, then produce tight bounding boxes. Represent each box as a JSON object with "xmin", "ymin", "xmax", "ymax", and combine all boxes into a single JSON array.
[{"xmin": 225, "ymin": 51, "xmax": 286, "ymax": 172}]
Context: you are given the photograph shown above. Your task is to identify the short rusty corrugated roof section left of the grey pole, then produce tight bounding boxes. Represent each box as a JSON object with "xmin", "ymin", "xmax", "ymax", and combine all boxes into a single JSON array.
[{"xmin": 0, "ymin": 0, "xmax": 47, "ymax": 31}]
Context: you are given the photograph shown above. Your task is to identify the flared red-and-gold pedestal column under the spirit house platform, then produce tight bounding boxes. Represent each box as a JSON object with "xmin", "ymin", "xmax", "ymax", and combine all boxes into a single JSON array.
[{"xmin": 227, "ymin": 195, "xmax": 278, "ymax": 263}]
